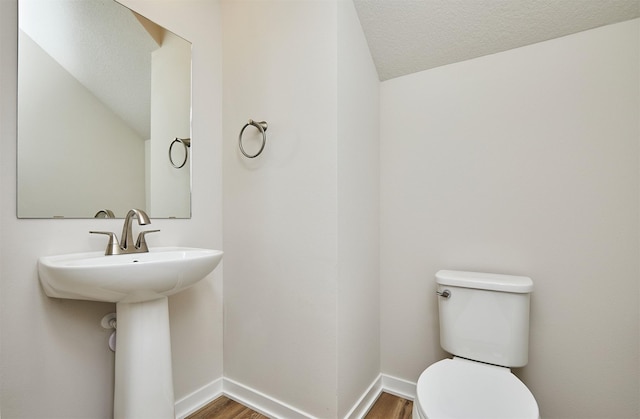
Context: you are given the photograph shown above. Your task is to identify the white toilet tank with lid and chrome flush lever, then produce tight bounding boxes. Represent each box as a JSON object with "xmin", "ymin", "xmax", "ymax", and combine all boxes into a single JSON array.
[{"xmin": 436, "ymin": 270, "xmax": 533, "ymax": 367}]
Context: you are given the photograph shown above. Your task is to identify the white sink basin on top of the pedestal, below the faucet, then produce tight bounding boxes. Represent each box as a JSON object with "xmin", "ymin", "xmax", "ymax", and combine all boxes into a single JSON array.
[{"xmin": 38, "ymin": 247, "xmax": 223, "ymax": 303}]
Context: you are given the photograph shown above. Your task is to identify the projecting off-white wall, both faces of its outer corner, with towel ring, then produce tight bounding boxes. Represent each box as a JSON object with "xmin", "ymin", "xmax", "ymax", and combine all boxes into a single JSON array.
[{"xmin": 222, "ymin": 1, "xmax": 379, "ymax": 418}]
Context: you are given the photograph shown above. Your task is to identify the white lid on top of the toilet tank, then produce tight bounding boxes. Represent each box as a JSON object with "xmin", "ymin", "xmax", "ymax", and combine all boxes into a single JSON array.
[{"xmin": 436, "ymin": 270, "xmax": 533, "ymax": 294}]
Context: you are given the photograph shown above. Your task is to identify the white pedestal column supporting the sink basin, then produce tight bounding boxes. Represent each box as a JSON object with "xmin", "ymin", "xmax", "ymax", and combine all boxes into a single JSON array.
[{"xmin": 113, "ymin": 297, "xmax": 175, "ymax": 419}]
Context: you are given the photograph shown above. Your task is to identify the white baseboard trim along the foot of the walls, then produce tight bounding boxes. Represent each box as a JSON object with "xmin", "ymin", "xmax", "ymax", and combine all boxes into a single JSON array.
[{"xmin": 176, "ymin": 374, "xmax": 416, "ymax": 419}]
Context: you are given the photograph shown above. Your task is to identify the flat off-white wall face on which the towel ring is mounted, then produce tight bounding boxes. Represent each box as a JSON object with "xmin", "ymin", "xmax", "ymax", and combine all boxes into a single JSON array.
[{"xmin": 222, "ymin": 1, "xmax": 337, "ymax": 417}]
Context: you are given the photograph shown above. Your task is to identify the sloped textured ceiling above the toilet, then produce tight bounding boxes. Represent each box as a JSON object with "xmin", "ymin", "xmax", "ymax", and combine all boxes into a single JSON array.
[{"xmin": 354, "ymin": 0, "xmax": 640, "ymax": 80}]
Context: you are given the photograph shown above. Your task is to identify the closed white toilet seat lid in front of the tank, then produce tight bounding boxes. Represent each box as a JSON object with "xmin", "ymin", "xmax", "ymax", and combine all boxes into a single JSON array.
[{"xmin": 414, "ymin": 358, "xmax": 540, "ymax": 419}]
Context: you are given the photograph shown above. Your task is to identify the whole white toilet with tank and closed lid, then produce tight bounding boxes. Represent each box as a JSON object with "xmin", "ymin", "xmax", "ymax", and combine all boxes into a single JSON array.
[{"xmin": 413, "ymin": 271, "xmax": 540, "ymax": 419}]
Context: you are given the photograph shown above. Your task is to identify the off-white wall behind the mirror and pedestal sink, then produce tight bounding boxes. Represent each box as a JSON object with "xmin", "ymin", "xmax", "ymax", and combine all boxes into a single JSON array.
[{"xmin": 0, "ymin": 0, "xmax": 222, "ymax": 419}]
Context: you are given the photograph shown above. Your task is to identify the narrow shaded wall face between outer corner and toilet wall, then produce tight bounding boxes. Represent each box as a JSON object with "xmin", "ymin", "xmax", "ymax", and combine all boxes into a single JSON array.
[{"xmin": 337, "ymin": 1, "xmax": 380, "ymax": 417}]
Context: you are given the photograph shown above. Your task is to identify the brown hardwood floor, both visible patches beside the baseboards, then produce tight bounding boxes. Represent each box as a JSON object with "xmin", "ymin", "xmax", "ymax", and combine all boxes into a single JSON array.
[{"xmin": 185, "ymin": 393, "xmax": 413, "ymax": 419}]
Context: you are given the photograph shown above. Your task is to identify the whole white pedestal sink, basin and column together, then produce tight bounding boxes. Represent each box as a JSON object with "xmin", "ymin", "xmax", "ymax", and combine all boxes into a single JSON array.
[{"xmin": 38, "ymin": 247, "xmax": 222, "ymax": 419}]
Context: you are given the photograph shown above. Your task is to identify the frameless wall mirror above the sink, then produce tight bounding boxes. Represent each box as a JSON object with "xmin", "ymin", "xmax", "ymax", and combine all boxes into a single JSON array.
[{"xmin": 17, "ymin": 0, "xmax": 193, "ymax": 218}]
